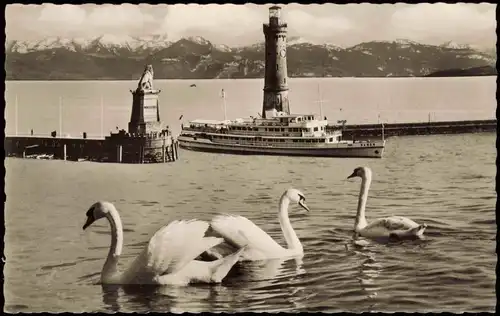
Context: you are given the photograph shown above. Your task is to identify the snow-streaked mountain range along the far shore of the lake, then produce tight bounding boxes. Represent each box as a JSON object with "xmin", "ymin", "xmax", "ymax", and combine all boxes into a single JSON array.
[{"xmin": 5, "ymin": 35, "xmax": 496, "ymax": 80}]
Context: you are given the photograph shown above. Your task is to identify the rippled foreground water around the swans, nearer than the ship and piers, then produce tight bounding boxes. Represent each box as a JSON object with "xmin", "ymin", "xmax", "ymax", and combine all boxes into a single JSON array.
[{"xmin": 5, "ymin": 135, "xmax": 496, "ymax": 312}]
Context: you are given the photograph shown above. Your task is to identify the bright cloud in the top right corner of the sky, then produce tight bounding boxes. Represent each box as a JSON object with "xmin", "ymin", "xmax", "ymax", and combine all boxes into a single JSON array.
[{"xmin": 391, "ymin": 3, "xmax": 496, "ymax": 39}]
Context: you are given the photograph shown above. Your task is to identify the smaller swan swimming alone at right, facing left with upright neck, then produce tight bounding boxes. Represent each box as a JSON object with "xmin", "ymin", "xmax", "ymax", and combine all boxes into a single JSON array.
[{"xmin": 347, "ymin": 167, "xmax": 427, "ymax": 239}]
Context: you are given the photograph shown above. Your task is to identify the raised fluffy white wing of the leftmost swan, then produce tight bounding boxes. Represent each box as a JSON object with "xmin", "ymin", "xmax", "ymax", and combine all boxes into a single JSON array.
[{"xmin": 146, "ymin": 220, "xmax": 224, "ymax": 275}]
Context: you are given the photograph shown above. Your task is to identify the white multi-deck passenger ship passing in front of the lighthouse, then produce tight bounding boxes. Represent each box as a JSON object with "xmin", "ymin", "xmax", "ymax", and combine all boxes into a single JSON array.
[{"xmin": 178, "ymin": 112, "xmax": 385, "ymax": 158}]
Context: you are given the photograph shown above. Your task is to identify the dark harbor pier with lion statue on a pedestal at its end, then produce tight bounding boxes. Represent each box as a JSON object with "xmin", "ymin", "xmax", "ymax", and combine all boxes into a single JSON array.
[{"xmin": 4, "ymin": 65, "xmax": 179, "ymax": 163}]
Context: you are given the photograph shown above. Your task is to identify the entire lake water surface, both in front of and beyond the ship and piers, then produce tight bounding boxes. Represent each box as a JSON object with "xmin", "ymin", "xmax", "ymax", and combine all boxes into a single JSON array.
[{"xmin": 4, "ymin": 78, "xmax": 496, "ymax": 312}]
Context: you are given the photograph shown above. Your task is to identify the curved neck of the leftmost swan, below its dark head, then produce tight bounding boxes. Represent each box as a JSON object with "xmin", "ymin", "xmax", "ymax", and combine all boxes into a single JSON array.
[{"xmin": 102, "ymin": 209, "xmax": 123, "ymax": 279}]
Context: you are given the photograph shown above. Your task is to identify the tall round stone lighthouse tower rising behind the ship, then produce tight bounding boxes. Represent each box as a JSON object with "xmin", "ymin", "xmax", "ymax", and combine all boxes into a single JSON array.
[{"xmin": 262, "ymin": 6, "xmax": 290, "ymax": 118}]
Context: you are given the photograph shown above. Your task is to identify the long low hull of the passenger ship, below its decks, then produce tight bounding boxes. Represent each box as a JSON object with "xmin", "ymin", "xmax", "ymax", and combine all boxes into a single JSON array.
[{"xmin": 178, "ymin": 136, "xmax": 384, "ymax": 158}]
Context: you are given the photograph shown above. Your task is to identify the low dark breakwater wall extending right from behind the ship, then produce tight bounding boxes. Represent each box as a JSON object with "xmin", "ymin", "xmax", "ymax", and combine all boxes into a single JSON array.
[{"xmin": 327, "ymin": 120, "xmax": 497, "ymax": 139}]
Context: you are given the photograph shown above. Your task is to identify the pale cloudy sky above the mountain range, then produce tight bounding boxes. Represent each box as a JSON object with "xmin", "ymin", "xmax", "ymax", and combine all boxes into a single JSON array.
[{"xmin": 5, "ymin": 3, "xmax": 496, "ymax": 48}]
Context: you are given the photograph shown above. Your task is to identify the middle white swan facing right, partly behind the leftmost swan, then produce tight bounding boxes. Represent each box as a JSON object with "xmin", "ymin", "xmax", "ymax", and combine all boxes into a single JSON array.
[{"xmin": 210, "ymin": 189, "xmax": 309, "ymax": 261}]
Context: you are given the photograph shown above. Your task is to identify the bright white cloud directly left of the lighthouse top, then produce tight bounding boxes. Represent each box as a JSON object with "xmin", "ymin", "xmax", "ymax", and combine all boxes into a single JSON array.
[{"xmin": 161, "ymin": 4, "xmax": 267, "ymax": 40}]
